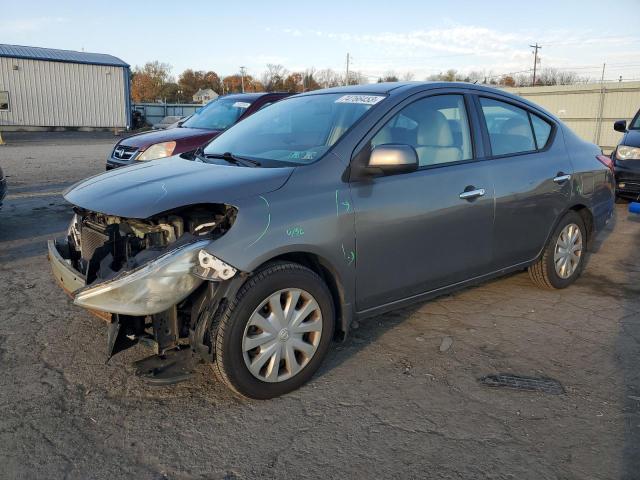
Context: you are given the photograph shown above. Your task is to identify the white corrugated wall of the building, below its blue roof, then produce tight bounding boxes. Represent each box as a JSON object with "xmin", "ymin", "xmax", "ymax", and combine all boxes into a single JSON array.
[{"xmin": 0, "ymin": 57, "xmax": 128, "ymax": 128}]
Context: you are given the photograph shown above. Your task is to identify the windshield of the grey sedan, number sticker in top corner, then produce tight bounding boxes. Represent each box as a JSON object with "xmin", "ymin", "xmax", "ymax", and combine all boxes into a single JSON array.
[{"xmin": 204, "ymin": 93, "xmax": 385, "ymax": 165}]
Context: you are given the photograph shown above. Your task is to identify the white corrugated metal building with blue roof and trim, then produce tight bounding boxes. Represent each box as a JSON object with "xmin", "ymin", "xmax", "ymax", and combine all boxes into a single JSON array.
[{"xmin": 0, "ymin": 44, "xmax": 131, "ymax": 130}]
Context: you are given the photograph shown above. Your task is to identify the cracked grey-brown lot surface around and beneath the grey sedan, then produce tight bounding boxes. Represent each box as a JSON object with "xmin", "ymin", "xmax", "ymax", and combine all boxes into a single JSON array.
[{"xmin": 0, "ymin": 134, "xmax": 640, "ymax": 480}]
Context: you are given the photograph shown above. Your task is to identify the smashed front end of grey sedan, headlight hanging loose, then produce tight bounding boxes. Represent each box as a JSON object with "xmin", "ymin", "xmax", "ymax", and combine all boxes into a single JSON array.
[{"xmin": 49, "ymin": 204, "xmax": 242, "ymax": 376}]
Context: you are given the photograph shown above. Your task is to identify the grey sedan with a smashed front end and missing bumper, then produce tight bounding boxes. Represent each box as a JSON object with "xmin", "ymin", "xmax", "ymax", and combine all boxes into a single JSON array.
[{"xmin": 49, "ymin": 83, "xmax": 614, "ymax": 398}]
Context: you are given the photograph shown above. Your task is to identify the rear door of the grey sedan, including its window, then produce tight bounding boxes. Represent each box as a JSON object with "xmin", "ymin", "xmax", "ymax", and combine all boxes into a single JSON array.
[{"xmin": 477, "ymin": 96, "xmax": 573, "ymax": 270}]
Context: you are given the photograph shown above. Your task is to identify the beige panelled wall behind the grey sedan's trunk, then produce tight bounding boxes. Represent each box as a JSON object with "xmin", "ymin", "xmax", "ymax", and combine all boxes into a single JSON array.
[{"xmin": 504, "ymin": 82, "xmax": 640, "ymax": 152}]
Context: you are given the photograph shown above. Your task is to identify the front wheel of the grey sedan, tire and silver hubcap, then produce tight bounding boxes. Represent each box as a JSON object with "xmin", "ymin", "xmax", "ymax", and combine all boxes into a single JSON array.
[{"xmin": 211, "ymin": 262, "xmax": 335, "ymax": 399}]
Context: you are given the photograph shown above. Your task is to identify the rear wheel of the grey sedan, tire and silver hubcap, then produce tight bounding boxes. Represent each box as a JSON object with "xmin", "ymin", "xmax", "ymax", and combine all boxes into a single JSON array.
[{"xmin": 529, "ymin": 211, "xmax": 587, "ymax": 289}]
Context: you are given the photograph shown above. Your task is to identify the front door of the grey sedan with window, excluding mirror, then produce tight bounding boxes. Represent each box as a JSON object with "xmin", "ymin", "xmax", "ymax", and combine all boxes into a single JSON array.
[{"xmin": 351, "ymin": 93, "xmax": 493, "ymax": 311}]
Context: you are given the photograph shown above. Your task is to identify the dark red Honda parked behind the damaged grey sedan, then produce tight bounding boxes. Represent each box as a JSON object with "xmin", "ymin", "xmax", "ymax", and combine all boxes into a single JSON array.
[{"xmin": 107, "ymin": 92, "xmax": 291, "ymax": 170}]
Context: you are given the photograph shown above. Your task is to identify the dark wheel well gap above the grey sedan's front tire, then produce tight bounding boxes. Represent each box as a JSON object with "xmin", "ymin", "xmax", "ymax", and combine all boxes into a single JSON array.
[{"xmin": 269, "ymin": 252, "xmax": 350, "ymax": 338}]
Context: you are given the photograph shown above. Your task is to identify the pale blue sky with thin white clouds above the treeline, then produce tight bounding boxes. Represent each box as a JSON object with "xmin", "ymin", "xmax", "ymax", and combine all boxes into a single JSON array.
[{"xmin": 0, "ymin": 0, "xmax": 640, "ymax": 81}]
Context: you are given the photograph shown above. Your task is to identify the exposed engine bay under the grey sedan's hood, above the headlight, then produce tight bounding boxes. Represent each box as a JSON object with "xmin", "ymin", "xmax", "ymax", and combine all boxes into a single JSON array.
[{"xmin": 67, "ymin": 205, "xmax": 236, "ymax": 285}]
